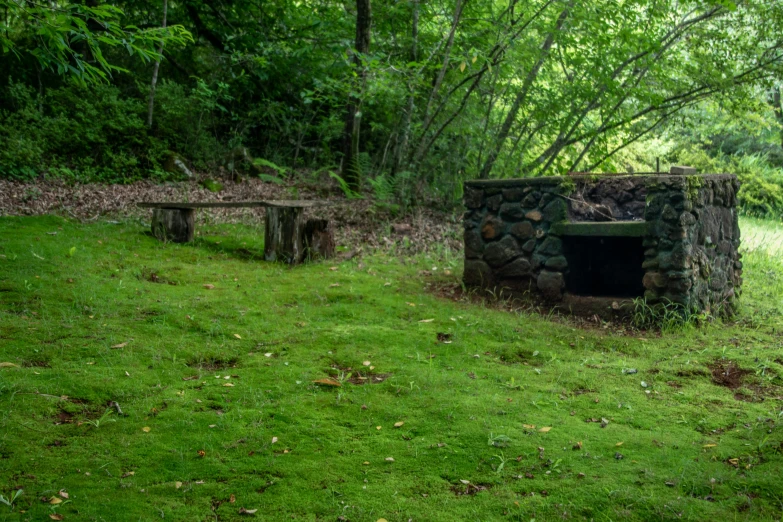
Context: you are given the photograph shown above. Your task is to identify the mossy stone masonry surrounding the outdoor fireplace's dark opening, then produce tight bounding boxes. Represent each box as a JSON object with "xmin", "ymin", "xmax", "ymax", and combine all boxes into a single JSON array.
[{"xmin": 463, "ymin": 175, "xmax": 742, "ymax": 314}]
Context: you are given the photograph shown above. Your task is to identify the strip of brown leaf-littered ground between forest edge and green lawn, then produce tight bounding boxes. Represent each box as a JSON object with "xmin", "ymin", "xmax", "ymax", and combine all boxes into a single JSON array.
[{"xmin": 0, "ymin": 179, "xmax": 462, "ymax": 252}]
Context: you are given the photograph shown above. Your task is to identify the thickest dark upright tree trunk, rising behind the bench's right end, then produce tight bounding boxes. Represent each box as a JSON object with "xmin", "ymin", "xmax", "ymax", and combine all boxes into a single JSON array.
[{"xmin": 342, "ymin": 0, "xmax": 372, "ymax": 192}]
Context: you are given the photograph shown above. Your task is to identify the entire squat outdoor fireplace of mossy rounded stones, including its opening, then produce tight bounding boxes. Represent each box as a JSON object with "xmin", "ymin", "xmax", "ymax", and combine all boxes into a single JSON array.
[{"xmin": 463, "ymin": 168, "xmax": 742, "ymax": 316}]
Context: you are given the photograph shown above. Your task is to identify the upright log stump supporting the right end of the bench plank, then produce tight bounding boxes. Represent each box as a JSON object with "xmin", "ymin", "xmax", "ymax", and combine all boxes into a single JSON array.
[{"xmin": 264, "ymin": 207, "xmax": 304, "ymax": 265}]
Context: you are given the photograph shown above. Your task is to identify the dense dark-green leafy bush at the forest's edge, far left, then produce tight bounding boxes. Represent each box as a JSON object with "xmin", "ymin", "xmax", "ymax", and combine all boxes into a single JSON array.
[{"xmin": 0, "ymin": 79, "xmax": 173, "ymax": 183}]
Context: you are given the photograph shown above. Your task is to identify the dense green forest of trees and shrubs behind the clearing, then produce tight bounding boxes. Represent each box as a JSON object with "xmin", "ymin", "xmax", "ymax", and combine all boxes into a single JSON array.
[{"xmin": 0, "ymin": 0, "xmax": 783, "ymax": 218}]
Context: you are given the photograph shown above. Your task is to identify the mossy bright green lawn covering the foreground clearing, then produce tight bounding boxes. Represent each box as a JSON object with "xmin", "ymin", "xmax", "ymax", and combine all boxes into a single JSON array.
[{"xmin": 0, "ymin": 213, "xmax": 783, "ymax": 522}]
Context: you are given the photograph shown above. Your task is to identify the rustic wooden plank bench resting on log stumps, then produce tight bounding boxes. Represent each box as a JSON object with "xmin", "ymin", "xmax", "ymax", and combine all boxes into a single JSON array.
[{"xmin": 137, "ymin": 200, "xmax": 334, "ymax": 264}]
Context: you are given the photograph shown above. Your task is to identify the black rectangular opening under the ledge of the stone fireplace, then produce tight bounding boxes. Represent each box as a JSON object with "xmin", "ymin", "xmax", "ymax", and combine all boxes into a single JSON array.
[{"xmin": 563, "ymin": 236, "xmax": 644, "ymax": 297}]
